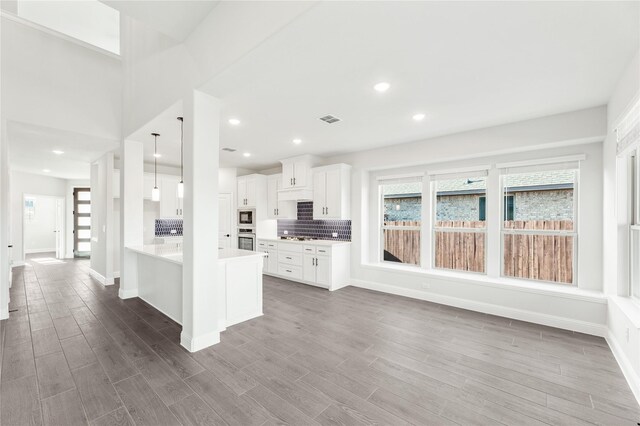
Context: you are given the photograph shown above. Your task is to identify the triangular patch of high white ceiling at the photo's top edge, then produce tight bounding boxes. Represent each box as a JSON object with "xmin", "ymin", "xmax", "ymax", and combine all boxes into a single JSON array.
[{"xmin": 100, "ymin": 0, "xmax": 219, "ymax": 42}]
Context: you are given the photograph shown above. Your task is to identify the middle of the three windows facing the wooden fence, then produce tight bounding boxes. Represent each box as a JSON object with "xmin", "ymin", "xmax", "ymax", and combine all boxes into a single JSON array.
[{"xmin": 432, "ymin": 172, "xmax": 487, "ymax": 273}]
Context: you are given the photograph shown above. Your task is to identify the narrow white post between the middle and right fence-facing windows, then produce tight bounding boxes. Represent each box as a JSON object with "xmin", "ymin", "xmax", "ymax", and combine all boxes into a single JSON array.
[{"xmin": 485, "ymin": 168, "xmax": 504, "ymax": 277}]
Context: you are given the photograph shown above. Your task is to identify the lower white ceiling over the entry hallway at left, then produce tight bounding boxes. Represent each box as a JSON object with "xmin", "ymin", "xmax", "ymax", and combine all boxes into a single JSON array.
[{"xmin": 7, "ymin": 122, "xmax": 119, "ymax": 179}]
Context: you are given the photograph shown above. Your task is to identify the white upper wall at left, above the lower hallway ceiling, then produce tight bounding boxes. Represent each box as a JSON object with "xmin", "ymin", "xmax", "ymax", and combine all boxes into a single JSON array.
[{"xmin": 0, "ymin": 15, "xmax": 122, "ymax": 140}]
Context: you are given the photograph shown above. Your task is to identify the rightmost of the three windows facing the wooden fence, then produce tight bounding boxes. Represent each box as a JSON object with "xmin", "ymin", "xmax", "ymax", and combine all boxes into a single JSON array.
[{"xmin": 502, "ymin": 168, "xmax": 578, "ymax": 284}]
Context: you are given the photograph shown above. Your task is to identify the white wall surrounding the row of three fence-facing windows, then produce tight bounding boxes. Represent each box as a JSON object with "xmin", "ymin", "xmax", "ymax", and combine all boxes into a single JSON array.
[{"xmin": 326, "ymin": 107, "xmax": 607, "ymax": 335}]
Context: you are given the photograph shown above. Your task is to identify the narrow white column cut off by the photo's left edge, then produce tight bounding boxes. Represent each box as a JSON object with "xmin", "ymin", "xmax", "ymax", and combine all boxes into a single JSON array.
[{"xmin": 0, "ymin": 119, "xmax": 11, "ymax": 320}]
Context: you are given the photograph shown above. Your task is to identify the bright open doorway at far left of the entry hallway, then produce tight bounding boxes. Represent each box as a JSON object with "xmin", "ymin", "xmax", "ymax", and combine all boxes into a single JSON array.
[{"xmin": 22, "ymin": 194, "xmax": 65, "ymax": 259}]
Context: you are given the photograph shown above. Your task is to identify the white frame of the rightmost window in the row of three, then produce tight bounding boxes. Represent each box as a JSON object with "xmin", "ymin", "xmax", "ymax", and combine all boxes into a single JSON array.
[{"xmin": 499, "ymin": 163, "xmax": 580, "ymax": 288}]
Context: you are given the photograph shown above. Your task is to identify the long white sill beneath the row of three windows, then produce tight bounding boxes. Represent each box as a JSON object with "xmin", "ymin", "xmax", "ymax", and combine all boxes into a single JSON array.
[{"xmin": 362, "ymin": 262, "xmax": 604, "ymax": 304}]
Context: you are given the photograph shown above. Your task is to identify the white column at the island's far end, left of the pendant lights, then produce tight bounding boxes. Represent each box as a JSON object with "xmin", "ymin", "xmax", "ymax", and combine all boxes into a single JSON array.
[{"xmin": 119, "ymin": 140, "xmax": 144, "ymax": 299}]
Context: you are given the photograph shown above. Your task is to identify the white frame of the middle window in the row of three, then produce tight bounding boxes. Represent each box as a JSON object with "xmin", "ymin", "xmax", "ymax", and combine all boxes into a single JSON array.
[{"xmin": 429, "ymin": 170, "xmax": 491, "ymax": 276}]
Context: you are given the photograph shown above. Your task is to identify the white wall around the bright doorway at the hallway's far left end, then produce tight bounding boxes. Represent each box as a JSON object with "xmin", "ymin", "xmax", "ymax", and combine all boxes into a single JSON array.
[{"xmin": 9, "ymin": 171, "xmax": 67, "ymax": 265}]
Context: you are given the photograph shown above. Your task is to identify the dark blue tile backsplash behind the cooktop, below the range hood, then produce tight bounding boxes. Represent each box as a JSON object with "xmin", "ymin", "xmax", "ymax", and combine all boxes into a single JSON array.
[{"xmin": 278, "ymin": 201, "xmax": 351, "ymax": 241}]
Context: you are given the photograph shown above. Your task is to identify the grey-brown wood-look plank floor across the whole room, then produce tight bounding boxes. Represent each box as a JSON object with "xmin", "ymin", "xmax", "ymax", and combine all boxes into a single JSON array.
[{"xmin": 0, "ymin": 255, "xmax": 640, "ymax": 426}]
